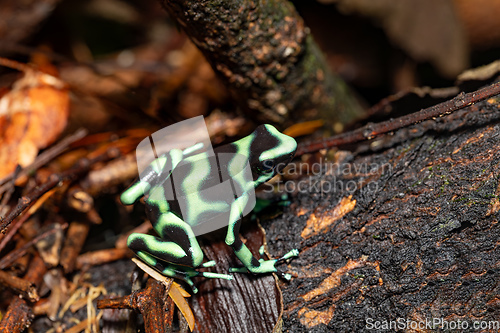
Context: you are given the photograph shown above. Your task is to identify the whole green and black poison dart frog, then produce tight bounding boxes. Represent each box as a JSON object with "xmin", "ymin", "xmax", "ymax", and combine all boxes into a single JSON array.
[{"xmin": 120, "ymin": 125, "xmax": 298, "ymax": 293}]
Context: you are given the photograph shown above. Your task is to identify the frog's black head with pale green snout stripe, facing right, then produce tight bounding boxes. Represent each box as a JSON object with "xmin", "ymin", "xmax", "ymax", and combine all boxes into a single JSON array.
[{"xmin": 249, "ymin": 125, "xmax": 297, "ymax": 181}]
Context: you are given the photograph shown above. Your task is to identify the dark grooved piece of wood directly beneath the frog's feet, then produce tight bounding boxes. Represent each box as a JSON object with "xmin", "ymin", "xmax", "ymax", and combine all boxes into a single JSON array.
[{"xmin": 189, "ymin": 223, "xmax": 283, "ymax": 333}]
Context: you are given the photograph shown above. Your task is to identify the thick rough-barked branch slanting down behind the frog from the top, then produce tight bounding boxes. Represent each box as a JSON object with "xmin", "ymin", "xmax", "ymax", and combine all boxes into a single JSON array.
[{"xmin": 160, "ymin": 0, "xmax": 361, "ymax": 124}]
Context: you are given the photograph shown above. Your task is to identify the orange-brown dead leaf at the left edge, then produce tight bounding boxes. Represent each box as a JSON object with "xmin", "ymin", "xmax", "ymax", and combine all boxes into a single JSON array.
[{"xmin": 0, "ymin": 59, "xmax": 69, "ymax": 179}]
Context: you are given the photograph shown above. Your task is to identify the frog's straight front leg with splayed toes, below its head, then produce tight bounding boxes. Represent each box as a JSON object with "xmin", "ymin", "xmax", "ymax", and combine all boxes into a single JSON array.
[{"xmin": 226, "ymin": 194, "xmax": 299, "ymax": 280}]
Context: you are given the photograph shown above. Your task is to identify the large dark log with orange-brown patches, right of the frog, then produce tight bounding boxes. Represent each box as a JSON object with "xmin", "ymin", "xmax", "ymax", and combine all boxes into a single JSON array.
[{"xmin": 263, "ymin": 87, "xmax": 500, "ymax": 332}]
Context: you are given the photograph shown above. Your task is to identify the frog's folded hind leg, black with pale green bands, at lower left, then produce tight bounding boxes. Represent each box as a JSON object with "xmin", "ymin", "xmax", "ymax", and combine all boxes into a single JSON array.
[{"xmin": 127, "ymin": 212, "xmax": 232, "ymax": 293}]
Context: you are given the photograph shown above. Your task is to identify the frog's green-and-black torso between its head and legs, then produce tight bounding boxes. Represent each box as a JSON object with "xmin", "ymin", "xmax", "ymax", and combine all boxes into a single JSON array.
[{"xmin": 146, "ymin": 145, "xmax": 253, "ymax": 230}]
